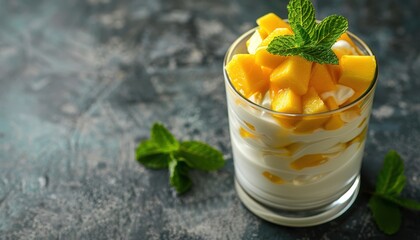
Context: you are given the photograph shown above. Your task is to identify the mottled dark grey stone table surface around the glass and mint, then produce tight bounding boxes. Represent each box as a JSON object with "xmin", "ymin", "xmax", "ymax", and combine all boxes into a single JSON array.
[{"xmin": 0, "ymin": 0, "xmax": 420, "ymax": 239}]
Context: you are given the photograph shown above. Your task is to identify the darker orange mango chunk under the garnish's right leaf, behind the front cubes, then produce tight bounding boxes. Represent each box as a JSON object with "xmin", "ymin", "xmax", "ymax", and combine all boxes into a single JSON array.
[{"xmin": 309, "ymin": 63, "xmax": 335, "ymax": 94}]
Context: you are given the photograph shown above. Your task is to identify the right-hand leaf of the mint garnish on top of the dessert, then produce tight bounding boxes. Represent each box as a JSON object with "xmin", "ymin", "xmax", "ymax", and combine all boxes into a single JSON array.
[{"xmin": 313, "ymin": 15, "xmax": 348, "ymax": 48}]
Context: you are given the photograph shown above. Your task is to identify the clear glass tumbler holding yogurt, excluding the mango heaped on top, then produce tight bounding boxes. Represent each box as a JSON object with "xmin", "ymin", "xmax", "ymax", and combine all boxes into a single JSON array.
[{"xmin": 224, "ymin": 29, "xmax": 378, "ymax": 226}]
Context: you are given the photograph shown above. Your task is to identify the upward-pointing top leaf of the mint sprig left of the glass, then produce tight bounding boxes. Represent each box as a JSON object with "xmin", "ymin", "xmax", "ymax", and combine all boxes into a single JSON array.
[{"xmin": 150, "ymin": 123, "xmax": 179, "ymax": 152}]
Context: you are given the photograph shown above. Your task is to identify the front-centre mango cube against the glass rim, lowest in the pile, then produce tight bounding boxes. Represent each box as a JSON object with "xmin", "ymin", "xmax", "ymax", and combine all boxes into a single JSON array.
[{"xmin": 271, "ymin": 88, "xmax": 302, "ymax": 128}]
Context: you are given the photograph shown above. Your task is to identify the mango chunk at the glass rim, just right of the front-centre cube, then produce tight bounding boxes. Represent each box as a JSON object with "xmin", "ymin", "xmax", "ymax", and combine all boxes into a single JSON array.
[{"xmin": 294, "ymin": 88, "xmax": 329, "ymax": 133}]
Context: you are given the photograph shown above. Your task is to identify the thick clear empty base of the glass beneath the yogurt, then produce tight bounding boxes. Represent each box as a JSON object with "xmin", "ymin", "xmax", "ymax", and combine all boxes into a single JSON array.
[{"xmin": 235, "ymin": 176, "xmax": 360, "ymax": 227}]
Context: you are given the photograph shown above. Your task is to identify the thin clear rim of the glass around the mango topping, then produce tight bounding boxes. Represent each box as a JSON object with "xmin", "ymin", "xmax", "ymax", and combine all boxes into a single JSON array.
[{"xmin": 223, "ymin": 27, "xmax": 378, "ymax": 117}]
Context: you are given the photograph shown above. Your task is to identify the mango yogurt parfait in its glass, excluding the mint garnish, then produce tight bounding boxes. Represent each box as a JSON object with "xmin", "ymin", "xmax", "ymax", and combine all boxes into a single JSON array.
[{"xmin": 224, "ymin": 0, "xmax": 377, "ymax": 226}]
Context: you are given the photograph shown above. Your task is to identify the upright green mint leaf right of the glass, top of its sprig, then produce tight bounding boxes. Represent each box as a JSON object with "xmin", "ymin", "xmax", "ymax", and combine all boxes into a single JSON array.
[{"xmin": 376, "ymin": 150, "xmax": 406, "ymax": 195}]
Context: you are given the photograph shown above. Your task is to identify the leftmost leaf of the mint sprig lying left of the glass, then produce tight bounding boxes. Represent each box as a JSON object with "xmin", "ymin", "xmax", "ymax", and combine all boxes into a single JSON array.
[{"xmin": 136, "ymin": 140, "xmax": 169, "ymax": 169}]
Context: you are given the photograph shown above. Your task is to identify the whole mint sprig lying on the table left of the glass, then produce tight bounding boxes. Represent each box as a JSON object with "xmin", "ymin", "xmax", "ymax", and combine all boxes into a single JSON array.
[{"xmin": 136, "ymin": 123, "xmax": 225, "ymax": 193}]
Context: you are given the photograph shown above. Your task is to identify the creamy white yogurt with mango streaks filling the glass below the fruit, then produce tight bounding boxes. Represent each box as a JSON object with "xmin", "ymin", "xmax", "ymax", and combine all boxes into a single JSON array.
[{"xmin": 227, "ymin": 80, "xmax": 372, "ymax": 209}]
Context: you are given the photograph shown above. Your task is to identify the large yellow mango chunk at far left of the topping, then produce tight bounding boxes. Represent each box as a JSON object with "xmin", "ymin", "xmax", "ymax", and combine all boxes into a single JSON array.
[{"xmin": 226, "ymin": 54, "xmax": 269, "ymax": 97}]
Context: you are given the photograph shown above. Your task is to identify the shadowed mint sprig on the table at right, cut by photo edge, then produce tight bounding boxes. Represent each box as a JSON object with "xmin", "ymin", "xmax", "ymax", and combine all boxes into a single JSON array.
[{"xmin": 369, "ymin": 150, "xmax": 420, "ymax": 235}]
